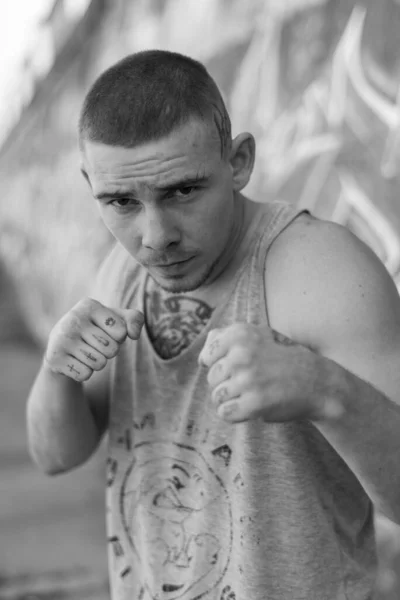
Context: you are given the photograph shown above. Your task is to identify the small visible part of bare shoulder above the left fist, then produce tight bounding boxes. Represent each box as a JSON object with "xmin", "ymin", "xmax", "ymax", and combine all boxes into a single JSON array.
[{"xmin": 90, "ymin": 242, "xmax": 142, "ymax": 307}]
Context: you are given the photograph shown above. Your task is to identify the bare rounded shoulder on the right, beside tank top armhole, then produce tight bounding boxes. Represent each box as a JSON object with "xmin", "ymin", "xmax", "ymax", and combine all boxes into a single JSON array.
[{"xmin": 265, "ymin": 215, "xmax": 396, "ymax": 341}]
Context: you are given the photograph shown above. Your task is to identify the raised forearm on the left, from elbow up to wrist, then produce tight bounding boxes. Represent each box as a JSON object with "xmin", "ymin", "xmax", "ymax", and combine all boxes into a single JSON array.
[{"xmin": 27, "ymin": 358, "xmax": 101, "ymax": 475}]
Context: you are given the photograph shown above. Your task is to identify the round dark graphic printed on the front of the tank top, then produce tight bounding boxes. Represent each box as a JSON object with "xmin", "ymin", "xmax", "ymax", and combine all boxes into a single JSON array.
[{"xmin": 119, "ymin": 442, "xmax": 232, "ymax": 600}]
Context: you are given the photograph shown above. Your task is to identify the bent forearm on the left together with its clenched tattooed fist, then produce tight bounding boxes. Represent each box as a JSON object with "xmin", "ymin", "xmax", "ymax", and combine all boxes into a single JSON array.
[{"xmin": 27, "ymin": 298, "xmax": 143, "ymax": 474}]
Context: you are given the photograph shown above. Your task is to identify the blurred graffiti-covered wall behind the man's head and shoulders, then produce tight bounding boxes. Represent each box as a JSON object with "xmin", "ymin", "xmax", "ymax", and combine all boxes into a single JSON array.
[{"xmin": 0, "ymin": 0, "xmax": 400, "ymax": 328}]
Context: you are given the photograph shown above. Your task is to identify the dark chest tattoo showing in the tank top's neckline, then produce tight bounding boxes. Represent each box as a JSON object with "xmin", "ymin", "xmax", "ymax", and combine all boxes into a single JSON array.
[{"xmin": 145, "ymin": 289, "xmax": 214, "ymax": 359}]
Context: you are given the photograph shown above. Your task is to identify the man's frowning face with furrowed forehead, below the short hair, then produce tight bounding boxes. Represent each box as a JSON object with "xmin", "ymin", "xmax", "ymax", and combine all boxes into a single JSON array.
[{"xmin": 83, "ymin": 120, "xmax": 234, "ymax": 292}]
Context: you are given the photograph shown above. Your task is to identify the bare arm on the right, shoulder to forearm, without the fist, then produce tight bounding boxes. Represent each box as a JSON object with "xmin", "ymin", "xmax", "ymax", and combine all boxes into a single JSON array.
[{"xmin": 266, "ymin": 221, "xmax": 400, "ymax": 522}]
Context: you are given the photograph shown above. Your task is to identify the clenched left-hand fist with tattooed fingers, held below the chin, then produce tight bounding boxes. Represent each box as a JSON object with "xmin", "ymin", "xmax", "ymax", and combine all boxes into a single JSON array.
[{"xmin": 44, "ymin": 298, "xmax": 144, "ymax": 382}]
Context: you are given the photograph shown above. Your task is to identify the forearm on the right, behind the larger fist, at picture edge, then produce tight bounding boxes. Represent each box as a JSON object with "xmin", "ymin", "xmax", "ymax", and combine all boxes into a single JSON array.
[{"xmin": 314, "ymin": 357, "xmax": 400, "ymax": 523}]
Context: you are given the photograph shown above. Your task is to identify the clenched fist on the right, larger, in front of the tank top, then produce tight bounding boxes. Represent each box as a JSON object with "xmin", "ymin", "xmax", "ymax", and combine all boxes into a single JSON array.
[{"xmin": 199, "ymin": 323, "xmax": 341, "ymax": 423}]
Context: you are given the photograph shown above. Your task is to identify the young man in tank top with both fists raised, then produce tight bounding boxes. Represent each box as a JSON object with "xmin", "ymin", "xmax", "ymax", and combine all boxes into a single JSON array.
[{"xmin": 27, "ymin": 51, "xmax": 400, "ymax": 600}]
